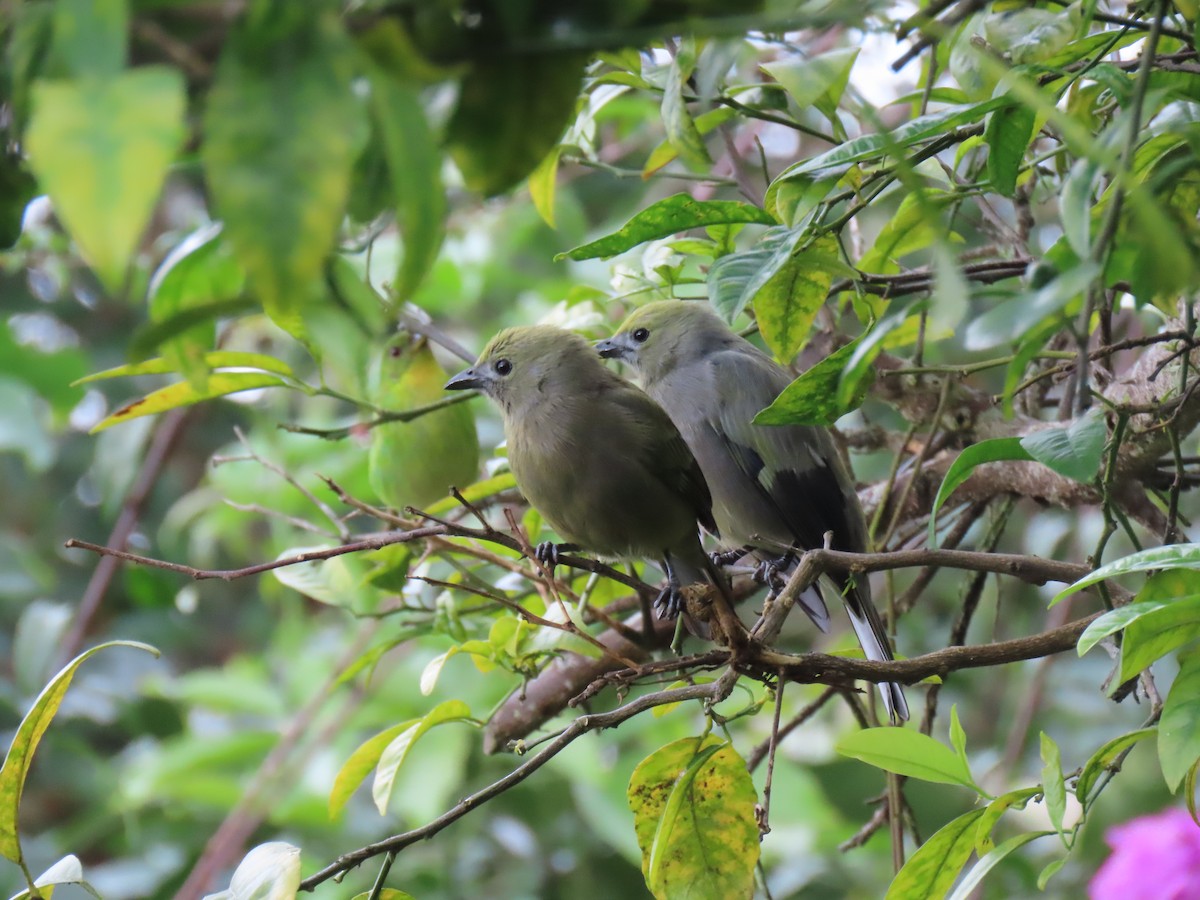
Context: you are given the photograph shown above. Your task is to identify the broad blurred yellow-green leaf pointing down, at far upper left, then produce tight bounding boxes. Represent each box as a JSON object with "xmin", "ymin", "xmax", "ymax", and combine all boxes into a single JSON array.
[{"xmin": 25, "ymin": 66, "xmax": 186, "ymax": 294}]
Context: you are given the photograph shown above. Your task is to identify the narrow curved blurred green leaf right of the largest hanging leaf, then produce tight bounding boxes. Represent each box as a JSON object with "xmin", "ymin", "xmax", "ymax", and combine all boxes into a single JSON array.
[{"xmin": 370, "ymin": 67, "xmax": 446, "ymax": 300}]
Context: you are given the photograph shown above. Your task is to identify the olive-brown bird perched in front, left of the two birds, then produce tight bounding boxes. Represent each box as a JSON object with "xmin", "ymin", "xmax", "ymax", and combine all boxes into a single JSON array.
[{"xmin": 445, "ymin": 325, "xmax": 724, "ymax": 617}]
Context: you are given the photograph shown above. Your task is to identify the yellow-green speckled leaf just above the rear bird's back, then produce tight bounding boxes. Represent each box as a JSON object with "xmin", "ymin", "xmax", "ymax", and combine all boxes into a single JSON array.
[{"xmin": 752, "ymin": 235, "xmax": 846, "ymax": 365}]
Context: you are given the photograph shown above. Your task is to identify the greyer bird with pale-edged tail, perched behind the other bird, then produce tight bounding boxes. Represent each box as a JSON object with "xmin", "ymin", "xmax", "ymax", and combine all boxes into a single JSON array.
[{"xmin": 596, "ymin": 300, "xmax": 908, "ymax": 721}]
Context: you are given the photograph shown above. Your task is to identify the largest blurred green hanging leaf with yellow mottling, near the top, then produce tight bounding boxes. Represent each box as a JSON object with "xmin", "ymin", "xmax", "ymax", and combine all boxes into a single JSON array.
[{"xmin": 200, "ymin": 0, "xmax": 367, "ymax": 349}]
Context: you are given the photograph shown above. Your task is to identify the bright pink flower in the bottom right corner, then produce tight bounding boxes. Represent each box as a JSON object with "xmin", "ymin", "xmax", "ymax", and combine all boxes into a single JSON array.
[{"xmin": 1088, "ymin": 809, "xmax": 1200, "ymax": 900}]
